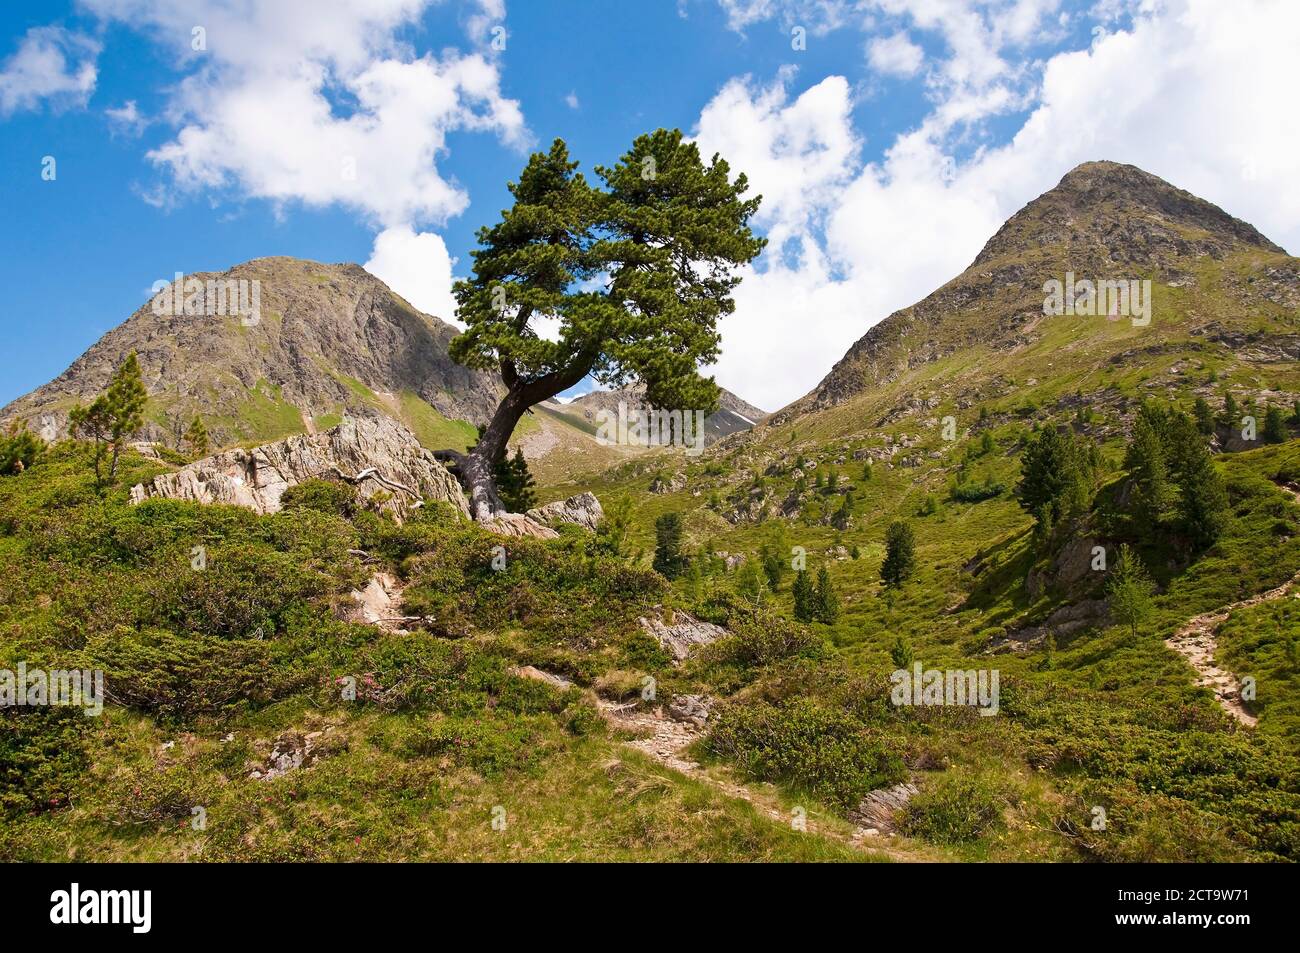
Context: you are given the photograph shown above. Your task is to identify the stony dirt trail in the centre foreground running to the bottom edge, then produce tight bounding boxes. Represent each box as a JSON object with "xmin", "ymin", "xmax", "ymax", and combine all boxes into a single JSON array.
[{"xmin": 598, "ymin": 698, "xmax": 939, "ymax": 863}]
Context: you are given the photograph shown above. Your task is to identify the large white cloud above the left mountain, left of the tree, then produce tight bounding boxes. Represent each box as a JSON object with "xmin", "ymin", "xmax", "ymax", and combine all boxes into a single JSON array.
[{"xmin": 85, "ymin": 0, "xmax": 529, "ymax": 228}]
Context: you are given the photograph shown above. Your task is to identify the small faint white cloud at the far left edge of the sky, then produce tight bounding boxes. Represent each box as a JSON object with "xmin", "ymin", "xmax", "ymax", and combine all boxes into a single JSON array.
[{"xmin": 0, "ymin": 26, "xmax": 100, "ymax": 116}]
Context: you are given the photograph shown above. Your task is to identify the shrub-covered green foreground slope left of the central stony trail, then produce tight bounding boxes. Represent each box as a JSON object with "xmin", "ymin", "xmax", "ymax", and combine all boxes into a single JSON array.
[{"xmin": 0, "ymin": 446, "xmax": 865, "ymax": 861}]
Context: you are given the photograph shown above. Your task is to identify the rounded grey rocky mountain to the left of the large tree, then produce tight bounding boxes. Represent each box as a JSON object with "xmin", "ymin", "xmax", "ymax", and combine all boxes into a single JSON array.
[{"xmin": 0, "ymin": 257, "xmax": 501, "ymax": 447}]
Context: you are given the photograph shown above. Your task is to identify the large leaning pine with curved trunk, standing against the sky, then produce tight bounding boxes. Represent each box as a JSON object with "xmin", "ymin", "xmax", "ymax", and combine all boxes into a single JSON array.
[{"xmin": 452, "ymin": 129, "xmax": 766, "ymax": 520}]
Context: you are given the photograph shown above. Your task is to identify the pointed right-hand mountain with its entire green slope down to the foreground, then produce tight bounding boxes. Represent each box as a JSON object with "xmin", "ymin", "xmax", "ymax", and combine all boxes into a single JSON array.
[{"xmin": 541, "ymin": 163, "xmax": 1300, "ymax": 862}]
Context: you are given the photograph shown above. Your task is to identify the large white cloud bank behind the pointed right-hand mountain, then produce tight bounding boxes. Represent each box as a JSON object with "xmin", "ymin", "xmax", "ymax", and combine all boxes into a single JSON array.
[{"xmin": 699, "ymin": 0, "xmax": 1300, "ymax": 407}]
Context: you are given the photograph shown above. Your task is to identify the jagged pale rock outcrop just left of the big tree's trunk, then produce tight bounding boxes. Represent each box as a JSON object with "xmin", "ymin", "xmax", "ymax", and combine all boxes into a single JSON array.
[{"xmin": 131, "ymin": 417, "xmax": 469, "ymax": 519}]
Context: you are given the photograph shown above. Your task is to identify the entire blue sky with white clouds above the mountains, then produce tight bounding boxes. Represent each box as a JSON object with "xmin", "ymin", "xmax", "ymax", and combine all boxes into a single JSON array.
[{"xmin": 0, "ymin": 0, "xmax": 1300, "ymax": 410}]
